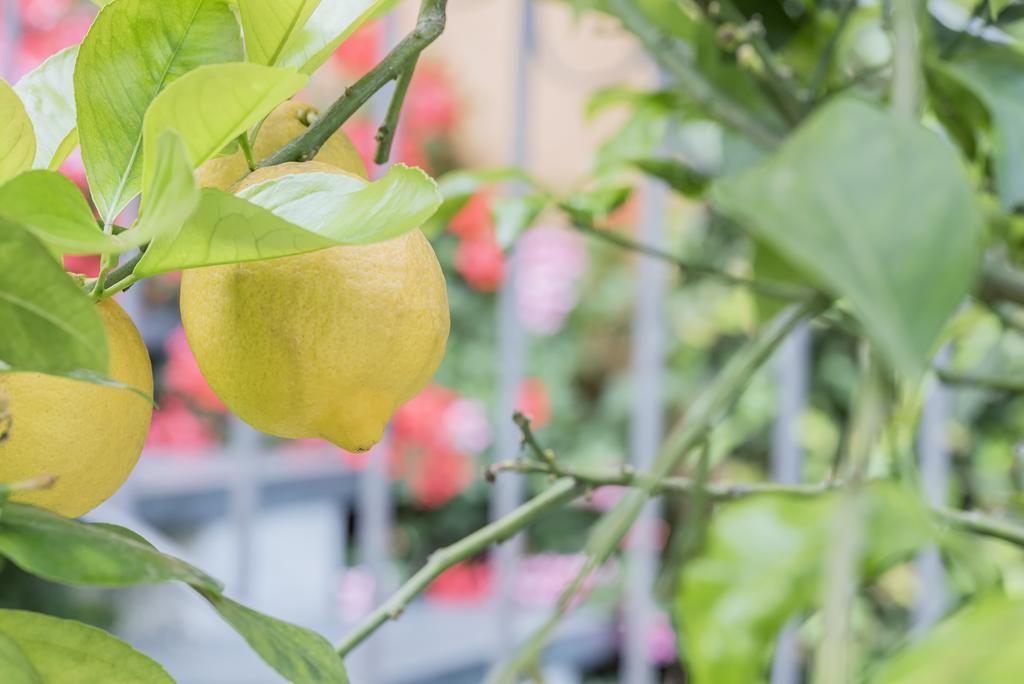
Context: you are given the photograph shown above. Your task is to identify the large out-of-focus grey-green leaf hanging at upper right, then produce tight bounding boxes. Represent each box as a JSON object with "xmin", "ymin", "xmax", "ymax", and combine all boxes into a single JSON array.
[{"xmin": 711, "ymin": 99, "xmax": 982, "ymax": 377}]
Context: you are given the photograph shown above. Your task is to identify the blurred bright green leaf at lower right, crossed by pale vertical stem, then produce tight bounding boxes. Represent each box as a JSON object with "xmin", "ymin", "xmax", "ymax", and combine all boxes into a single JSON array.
[{"xmin": 676, "ymin": 484, "xmax": 936, "ymax": 684}]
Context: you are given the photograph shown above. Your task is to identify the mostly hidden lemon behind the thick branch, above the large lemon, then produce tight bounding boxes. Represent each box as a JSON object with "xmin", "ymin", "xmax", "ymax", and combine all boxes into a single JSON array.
[{"xmin": 196, "ymin": 100, "xmax": 367, "ymax": 190}]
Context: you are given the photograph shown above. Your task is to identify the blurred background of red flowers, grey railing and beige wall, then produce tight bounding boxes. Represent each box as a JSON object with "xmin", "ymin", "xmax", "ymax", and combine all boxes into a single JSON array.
[{"xmin": 0, "ymin": 0, "xmax": 1024, "ymax": 684}]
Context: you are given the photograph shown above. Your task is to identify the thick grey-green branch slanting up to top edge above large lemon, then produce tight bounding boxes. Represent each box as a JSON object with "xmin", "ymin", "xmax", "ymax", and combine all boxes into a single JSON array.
[{"xmin": 256, "ymin": 0, "xmax": 447, "ymax": 167}]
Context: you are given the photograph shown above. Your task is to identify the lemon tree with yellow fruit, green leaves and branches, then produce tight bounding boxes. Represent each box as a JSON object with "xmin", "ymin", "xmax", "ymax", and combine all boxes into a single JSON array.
[{"xmin": 6, "ymin": 0, "xmax": 1024, "ymax": 683}]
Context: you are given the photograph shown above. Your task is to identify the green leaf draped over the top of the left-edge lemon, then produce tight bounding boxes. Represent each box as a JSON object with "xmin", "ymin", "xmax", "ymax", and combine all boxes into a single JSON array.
[{"xmin": 0, "ymin": 219, "xmax": 108, "ymax": 374}]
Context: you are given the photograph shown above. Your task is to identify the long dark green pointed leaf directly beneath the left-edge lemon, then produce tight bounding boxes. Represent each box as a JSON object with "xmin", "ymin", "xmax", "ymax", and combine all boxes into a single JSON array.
[{"xmin": 0, "ymin": 503, "xmax": 220, "ymax": 592}]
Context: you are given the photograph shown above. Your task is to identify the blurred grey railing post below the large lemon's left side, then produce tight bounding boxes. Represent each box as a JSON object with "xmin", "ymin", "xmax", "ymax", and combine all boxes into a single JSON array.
[{"xmin": 227, "ymin": 416, "xmax": 262, "ymax": 599}]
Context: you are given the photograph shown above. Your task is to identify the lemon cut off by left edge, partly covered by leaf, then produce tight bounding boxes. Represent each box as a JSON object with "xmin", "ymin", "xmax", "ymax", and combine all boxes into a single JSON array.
[{"xmin": 0, "ymin": 299, "xmax": 153, "ymax": 517}]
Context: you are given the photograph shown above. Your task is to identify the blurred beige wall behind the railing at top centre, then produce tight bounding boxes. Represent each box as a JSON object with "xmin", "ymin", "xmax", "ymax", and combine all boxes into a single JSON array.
[{"xmin": 400, "ymin": 0, "xmax": 654, "ymax": 187}]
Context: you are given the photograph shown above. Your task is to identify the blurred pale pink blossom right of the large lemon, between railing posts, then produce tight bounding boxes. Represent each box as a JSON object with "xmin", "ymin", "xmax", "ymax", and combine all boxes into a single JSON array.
[{"xmin": 516, "ymin": 226, "xmax": 587, "ymax": 335}]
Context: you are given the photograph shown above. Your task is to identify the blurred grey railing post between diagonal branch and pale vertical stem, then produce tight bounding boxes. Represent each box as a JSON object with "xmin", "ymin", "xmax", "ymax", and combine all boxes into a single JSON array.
[{"xmin": 771, "ymin": 324, "xmax": 811, "ymax": 684}]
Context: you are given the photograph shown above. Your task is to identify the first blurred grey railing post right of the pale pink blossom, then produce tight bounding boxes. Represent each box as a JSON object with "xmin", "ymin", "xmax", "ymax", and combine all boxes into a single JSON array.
[{"xmin": 620, "ymin": 175, "xmax": 669, "ymax": 684}]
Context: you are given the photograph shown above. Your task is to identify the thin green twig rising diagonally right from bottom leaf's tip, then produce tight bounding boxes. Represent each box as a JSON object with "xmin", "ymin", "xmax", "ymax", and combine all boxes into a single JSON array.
[{"xmin": 337, "ymin": 479, "xmax": 583, "ymax": 657}]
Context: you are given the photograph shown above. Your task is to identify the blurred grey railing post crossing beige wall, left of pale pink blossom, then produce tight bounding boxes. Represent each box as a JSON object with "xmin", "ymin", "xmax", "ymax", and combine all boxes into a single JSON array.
[{"xmin": 490, "ymin": 0, "xmax": 535, "ymax": 658}]
